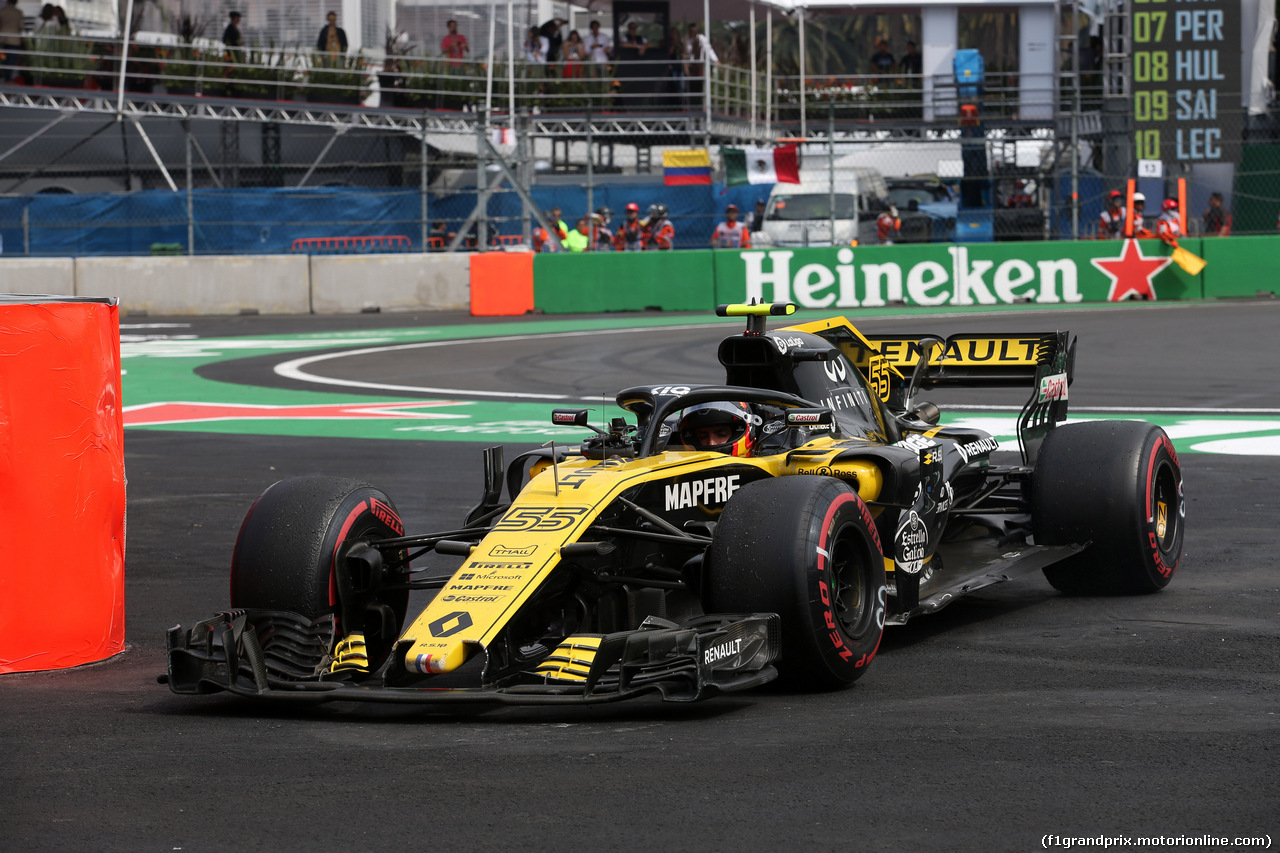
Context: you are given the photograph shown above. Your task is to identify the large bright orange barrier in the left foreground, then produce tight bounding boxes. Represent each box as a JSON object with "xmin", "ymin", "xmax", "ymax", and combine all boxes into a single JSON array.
[{"xmin": 0, "ymin": 296, "xmax": 124, "ymax": 672}]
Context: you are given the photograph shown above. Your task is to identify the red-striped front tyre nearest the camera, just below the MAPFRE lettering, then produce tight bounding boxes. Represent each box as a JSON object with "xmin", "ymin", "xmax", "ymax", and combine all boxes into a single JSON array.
[{"xmin": 703, "ymin": 476, "xmax": 886, "ymax": 689}]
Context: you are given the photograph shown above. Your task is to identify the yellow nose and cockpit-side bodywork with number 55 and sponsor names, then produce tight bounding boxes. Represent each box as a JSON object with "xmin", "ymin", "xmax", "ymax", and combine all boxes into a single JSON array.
[{"xmin": 402, "ymin": 438, "xmax": 882, "ymax": 678}]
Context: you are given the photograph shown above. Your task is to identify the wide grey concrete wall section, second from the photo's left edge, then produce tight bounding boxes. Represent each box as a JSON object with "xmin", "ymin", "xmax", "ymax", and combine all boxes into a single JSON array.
[{"xmin": 76, "ymin": 255, "xmax": 311, "ymax": 314}]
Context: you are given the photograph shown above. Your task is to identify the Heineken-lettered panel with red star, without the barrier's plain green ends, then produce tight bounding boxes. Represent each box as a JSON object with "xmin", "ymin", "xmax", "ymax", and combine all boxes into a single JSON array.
[{"xmin": 716, "ymin": 240, "xmax": 1203, "ymax": 309}]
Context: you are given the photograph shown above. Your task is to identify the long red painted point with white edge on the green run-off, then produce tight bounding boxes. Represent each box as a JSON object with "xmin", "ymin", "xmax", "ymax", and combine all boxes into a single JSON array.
[{"xmin": 124, "ymin": 400, "xmax": 466, "ymax": 427}]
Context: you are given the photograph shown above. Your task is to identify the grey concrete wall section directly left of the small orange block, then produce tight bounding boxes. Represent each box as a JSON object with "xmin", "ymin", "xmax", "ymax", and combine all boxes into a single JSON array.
[{"xmin": 311, "ymin": 254, "xmax": 471, "ymax": 314}]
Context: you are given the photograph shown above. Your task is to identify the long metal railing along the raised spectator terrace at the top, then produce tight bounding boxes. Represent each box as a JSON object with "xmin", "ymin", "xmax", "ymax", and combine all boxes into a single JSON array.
[{"xmin": 8, "ymin": 35, "xmax": 1101, "ymax": 123}]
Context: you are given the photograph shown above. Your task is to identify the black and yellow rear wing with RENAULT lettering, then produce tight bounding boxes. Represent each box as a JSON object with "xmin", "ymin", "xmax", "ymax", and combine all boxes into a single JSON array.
[{"xmin": 790, "ymin": 318, "xmax": 1075, "ymax": 465}]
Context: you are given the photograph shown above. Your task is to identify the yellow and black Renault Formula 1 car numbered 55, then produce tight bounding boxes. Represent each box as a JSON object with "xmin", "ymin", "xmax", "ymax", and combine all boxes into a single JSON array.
[{"xmin": 161, "ymin": 304, "xmax": 1184, "ymax": 704}]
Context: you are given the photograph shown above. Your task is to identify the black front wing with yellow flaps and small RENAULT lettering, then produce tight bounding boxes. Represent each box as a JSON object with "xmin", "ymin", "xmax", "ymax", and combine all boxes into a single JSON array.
[{"xmin": 160, "ymin": 610, "xmax": 781, "ymax": 704}]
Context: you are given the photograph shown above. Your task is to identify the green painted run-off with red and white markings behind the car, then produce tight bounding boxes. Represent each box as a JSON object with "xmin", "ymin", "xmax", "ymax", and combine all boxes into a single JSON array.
[{"xmin": 122, "ymin": 305, "xmax": 1280, "ymax": 456}]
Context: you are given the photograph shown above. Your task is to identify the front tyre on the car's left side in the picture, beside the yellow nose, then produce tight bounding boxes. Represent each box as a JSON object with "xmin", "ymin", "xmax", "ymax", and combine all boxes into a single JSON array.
[{"xmin": 230, "ymin": 476, "xmax": 408, "ymax": 669}]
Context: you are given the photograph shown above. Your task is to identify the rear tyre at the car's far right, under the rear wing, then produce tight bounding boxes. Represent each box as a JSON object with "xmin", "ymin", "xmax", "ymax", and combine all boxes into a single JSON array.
[{"xmin": 1032, "ymin": 420, "xmax": 1185, "ymax": 596}]
